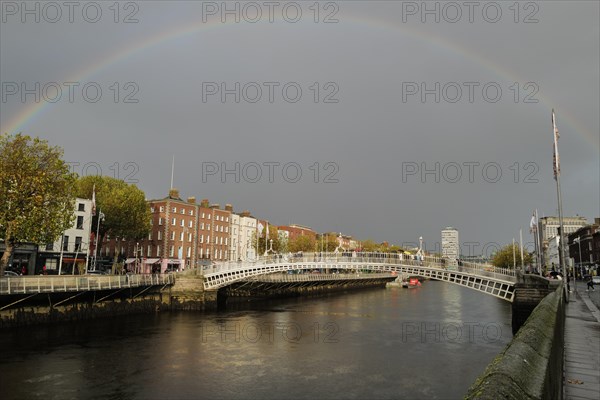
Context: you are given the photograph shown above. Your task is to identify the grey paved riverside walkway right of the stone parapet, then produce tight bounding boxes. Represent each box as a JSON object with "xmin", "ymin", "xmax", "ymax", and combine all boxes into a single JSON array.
[{"xmin": 563, "ymin": 282, "xmax": 600, "ymax": 400}]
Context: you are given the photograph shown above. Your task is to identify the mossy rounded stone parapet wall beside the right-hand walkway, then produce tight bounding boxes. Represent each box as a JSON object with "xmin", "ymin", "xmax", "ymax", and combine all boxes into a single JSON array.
[{"xmin": 465, "ymin": 284, "xmax": 565, "ymax": 399}]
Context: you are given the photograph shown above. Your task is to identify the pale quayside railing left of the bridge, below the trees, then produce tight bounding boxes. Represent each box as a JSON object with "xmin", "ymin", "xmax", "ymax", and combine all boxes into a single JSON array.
[{"xmin": 0, "ymin": 274, "xmax": 175, "ymax": 294}]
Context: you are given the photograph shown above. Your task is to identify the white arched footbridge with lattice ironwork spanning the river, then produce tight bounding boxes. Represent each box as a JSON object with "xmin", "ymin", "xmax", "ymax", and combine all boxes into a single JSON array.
[{"xmin": 203, "ymin": 252, "xmax": 517, "ymax": 302}]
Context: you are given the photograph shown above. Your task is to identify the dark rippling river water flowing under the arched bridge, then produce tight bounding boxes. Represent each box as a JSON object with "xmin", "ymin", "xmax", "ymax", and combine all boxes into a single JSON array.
[{"xmin": 0, "ymin": 281, "xmax": 512, "ymax": 400}]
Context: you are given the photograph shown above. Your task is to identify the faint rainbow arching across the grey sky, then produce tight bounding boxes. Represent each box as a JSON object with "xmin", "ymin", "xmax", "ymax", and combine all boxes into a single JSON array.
[{"xmin": 0, "ymin": 15, "xmax": 600, "ymax": 151}]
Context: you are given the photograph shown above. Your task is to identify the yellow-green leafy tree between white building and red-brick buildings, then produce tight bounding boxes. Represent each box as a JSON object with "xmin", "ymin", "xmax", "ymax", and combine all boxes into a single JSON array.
[{"xmin": 77, "ymin": 176, "xmax": 152, "ymax": 251}]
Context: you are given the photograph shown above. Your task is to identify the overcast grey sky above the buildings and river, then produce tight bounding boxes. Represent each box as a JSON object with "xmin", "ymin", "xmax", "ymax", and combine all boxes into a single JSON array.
[{"xmin": 0, "ymin": 0, "xmax": 600, "ymax": 253}]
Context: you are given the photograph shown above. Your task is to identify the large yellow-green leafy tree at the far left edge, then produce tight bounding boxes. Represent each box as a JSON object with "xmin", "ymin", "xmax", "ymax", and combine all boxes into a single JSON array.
[{"xmin": 0, "ymin": 134, "xmax": 77, "ymax": 276}]
